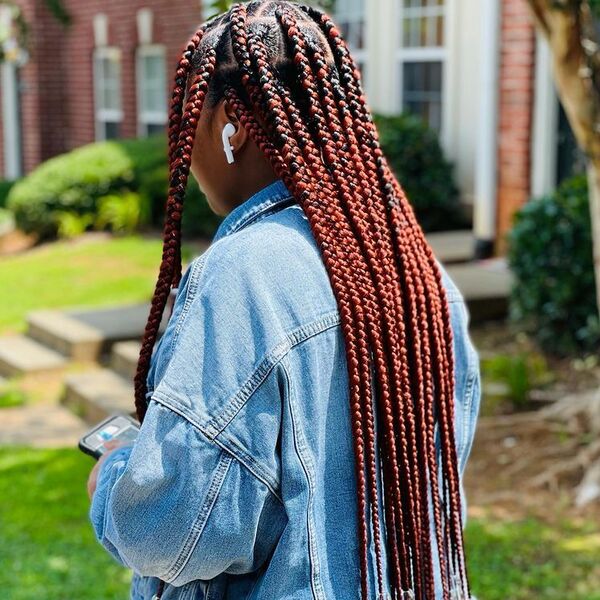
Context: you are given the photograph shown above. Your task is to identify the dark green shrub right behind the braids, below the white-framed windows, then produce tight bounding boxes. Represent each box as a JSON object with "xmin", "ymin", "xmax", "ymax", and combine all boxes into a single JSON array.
[{"xmin": 375, "ymin": 115, "xmax": 467, "ymax": 231}]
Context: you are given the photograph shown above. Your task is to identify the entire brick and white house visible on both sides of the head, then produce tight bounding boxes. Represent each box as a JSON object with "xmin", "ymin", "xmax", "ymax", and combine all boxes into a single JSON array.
[{"xmin": 0, "ymin": 0, "xmax": 573, "ymax": 256}]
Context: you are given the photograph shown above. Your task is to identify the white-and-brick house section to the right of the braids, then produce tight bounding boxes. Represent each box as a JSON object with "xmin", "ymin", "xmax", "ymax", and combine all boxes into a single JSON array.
[{"xmin": 336, "ymin": 0, "xmax": 575, "ymax": 256}]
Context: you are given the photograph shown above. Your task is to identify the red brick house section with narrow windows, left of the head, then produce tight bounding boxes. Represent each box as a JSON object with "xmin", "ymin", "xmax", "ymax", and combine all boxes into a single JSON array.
[{"xmin": 0, "ymin": 0, "xmax": 202, "ymax": 178}]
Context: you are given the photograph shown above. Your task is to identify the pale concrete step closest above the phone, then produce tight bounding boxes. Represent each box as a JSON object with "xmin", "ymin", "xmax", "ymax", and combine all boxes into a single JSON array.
[{"xmin": 62, "ymin": 369, "xmax": 135, "ymax": 424}]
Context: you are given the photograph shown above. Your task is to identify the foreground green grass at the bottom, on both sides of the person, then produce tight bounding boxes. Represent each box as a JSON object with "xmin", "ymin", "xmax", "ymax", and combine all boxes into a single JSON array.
[{"xmin": 0, "ymin": 448, "xmax": 600, "ymax": 600}]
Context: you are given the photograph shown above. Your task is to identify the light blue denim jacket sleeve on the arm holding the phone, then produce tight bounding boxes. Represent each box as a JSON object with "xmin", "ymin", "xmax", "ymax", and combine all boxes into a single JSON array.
[{"xmin": 90, "ymin": 253, "xmax": 287, "ymax": 586}]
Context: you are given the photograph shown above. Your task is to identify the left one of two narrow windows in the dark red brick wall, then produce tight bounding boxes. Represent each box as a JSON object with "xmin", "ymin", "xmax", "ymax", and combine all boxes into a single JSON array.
[{"xmin": 94, "ymin": 47, "xmax": 123, "ymax": 140}]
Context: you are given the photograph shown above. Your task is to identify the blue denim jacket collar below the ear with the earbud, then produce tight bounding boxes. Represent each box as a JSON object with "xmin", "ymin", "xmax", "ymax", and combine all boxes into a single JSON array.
[{"xmin": 213, "ymin": 179, "xmax": 295, "ymax": 243}]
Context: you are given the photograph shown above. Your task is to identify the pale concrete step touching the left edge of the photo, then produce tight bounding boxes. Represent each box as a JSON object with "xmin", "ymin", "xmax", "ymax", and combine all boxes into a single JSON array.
[{"xmin": 0, "ymin": 335, "xmax": 67, "ymax": 377}]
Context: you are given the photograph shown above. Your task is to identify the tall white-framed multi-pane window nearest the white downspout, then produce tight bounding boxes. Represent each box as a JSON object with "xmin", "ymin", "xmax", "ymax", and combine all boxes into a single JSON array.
[{"xmin": 398, "ymin": 0, "xmax": 446, "ymax": 132}]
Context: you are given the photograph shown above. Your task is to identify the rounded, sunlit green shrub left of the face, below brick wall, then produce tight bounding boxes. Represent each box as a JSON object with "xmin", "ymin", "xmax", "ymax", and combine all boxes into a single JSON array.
[{"xmin": 8, "ymin": 136, "xmax": 220, "ymax": 239}]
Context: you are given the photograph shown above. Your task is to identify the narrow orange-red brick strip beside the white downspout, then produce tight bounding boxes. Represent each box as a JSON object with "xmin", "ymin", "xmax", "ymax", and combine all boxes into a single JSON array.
[{"xmin": 497, "ymin": 0, "xmax": 535, "ymax": 250}]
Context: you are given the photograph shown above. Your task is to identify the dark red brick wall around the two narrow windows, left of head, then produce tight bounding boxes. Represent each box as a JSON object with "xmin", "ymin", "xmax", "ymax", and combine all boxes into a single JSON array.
[{"xmin": 0, "ymin": 0, "xmax": 201, "ymax": 177}]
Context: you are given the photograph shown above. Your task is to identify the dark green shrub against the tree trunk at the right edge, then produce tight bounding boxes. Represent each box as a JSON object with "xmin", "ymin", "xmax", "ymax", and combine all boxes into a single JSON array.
[{"xmin": 508, "ymin": 175, "xmax": 600, "ymax": 355}]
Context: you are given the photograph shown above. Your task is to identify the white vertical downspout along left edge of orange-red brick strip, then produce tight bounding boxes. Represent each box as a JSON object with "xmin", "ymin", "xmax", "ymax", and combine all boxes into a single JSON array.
[{"xmin": 473, "ymin": 0, "xmax": 500, "ymax": 242}]
